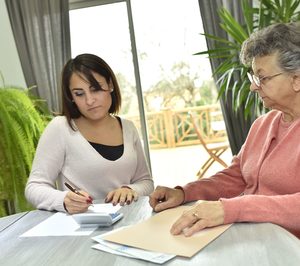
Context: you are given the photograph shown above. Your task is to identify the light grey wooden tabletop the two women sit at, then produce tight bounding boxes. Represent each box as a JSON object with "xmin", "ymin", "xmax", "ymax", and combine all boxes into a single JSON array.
[{"xmin": 0, "ymin": 197, "xmax": 300, "ymax": 266}]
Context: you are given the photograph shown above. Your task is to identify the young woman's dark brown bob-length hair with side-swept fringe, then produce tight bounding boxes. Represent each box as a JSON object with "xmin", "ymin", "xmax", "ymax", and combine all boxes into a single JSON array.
[{"xmin": 62, "ymin": 54, "xmax": 121, "ymax": 130}]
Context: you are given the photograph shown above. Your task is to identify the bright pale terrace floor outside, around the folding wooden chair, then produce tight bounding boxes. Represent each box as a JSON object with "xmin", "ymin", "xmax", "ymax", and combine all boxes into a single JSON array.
[{"xmin": 150, "ymin": 145, "xmax": 232, "ymax": 187}]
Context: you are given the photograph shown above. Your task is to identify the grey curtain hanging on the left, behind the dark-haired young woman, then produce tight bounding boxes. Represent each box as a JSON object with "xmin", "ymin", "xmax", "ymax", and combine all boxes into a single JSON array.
[{"xmin": 6, "ymin": 0, "xmax": 71, "ymax": 112}]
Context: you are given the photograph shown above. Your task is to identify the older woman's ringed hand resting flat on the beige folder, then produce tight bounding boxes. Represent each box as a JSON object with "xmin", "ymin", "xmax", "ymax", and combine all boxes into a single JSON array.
[{"xmin": 171, "ymin": 201, "xmax": 224, "ymax": 236}]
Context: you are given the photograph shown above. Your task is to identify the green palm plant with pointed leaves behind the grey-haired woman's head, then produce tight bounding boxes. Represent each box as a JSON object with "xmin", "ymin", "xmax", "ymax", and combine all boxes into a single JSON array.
[{"xmin": 197, "ymin": 0, "xmax": 300, "ymax": 118}]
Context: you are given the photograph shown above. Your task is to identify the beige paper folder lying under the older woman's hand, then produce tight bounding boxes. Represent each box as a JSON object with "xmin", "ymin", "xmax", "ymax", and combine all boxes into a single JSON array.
[{"xmin": 104, "ymin": 206, "xmax": 231, "ymax": 257}]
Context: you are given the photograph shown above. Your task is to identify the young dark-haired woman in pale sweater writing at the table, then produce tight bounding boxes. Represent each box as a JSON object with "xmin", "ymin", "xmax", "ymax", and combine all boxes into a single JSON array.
[{"xmin": 25, "ymin": 54, "xmax": 153, "ymax": 213}]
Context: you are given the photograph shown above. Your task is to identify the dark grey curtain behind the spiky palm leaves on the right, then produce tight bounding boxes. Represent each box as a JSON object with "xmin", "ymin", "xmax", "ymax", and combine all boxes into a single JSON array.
[{"xmin": 199, "ymin": 0, "xmax": 253, "ymax": 154}]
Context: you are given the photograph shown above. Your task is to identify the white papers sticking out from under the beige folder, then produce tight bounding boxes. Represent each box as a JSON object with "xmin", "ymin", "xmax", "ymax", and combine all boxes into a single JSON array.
[{"xmin": 92, "ymin": 227, "xmax": 175, "ymax": 264}]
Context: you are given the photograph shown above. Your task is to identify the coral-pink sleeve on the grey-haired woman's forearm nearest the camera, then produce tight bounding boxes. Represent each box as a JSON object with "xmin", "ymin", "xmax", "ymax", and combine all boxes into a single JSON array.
[{"xmin": 221, "ymin": 193, "xmax": 300, "ymax": 235}]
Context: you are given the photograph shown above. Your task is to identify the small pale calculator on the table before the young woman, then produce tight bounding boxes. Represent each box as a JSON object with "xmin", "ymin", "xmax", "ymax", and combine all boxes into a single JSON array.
[{"xmin": 72, "ymin": 212, "xmax": 123, "ymax": 227}]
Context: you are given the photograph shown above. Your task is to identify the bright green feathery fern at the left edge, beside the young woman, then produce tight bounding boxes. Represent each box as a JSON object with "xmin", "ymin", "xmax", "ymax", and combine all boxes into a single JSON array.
[{"xmin": 0, "ymin": 87, "xmax": 47, "ymax": 216}]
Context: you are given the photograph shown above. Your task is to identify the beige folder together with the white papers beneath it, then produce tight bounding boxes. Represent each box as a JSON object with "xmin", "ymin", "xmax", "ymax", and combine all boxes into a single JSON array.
[{"xmin": 93, "ymin": 206, "xmax": 230, "ymax": 263}]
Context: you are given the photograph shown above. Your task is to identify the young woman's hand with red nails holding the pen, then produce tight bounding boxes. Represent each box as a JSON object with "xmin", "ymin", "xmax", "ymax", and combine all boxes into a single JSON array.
[{"xmin": 64, "ymin": 191, "xmax": 92, "ymax": 214}]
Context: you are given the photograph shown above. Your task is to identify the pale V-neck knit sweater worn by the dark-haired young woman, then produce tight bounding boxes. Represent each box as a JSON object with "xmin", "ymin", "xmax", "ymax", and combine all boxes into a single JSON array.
[{"xmin": 25, "ymin": 116, "xmax": 153, "ymax": 211}]
